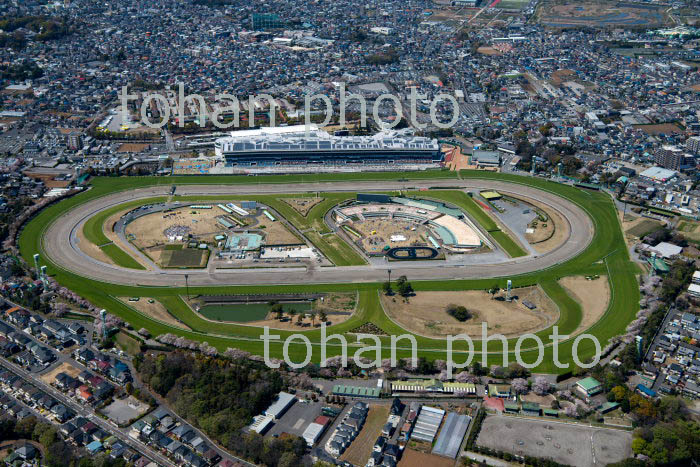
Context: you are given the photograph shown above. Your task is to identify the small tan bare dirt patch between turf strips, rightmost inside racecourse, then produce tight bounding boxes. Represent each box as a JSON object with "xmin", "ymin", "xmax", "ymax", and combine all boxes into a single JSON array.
[{"xmin": 559, "ymin": 276, "xmax": 610, "ymax": 334}]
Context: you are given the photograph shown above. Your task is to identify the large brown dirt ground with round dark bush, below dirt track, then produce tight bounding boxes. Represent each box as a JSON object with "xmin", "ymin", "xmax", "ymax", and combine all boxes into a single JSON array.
[{"xmin": 381, "ymin": 286, "xmax": 559, "ymax": 339}]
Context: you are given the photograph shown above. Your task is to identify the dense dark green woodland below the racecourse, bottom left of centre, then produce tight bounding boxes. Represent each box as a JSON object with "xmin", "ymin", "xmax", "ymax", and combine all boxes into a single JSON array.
[{"xmin": 135, "ymin": 351, "xmax": 306, "ymax": 466}]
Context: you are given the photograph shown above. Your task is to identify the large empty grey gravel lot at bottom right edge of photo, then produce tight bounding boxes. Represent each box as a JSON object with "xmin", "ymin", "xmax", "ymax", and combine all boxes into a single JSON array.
[{"xmin": 477, "ymin": 415, "xmax": 632, "ymax": 467}]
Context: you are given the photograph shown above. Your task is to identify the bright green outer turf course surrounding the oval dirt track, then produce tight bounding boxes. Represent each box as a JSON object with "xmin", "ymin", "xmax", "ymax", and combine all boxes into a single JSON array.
[{"xmin": 20, "ymin": 172, "xmax": 639, "ymax": 372}]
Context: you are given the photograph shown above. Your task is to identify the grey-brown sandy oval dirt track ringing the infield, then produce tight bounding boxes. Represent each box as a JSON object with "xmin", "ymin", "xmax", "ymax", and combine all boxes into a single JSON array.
[{"xmin": 43, "ymin": 180, "xmax": 593, "ymax": 286}]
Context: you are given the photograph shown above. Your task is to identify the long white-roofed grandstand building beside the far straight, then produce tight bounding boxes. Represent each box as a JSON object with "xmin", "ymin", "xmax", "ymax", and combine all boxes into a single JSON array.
[{"xmin": 214, "ymin": 125, "xmax": 443, "ymax": 167}]
